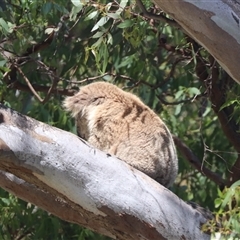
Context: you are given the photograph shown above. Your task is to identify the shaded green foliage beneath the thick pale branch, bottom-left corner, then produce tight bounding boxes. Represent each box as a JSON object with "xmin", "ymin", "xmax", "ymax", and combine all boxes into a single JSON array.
[{"xmin": 0, "ymin": 190, "xmax": 107, "ymax": 240}]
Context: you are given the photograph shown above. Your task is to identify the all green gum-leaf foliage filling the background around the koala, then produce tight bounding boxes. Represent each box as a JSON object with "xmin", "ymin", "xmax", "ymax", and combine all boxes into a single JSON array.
[{"xmin": 0, "ymin": 0, "xmax": 240, "ymax": 239}]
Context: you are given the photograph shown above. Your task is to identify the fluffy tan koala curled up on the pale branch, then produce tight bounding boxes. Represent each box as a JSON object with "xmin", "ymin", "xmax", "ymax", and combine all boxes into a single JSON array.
[{"xmin": 63, "ymin": 82, "xmax": 178, "ymax": 187}]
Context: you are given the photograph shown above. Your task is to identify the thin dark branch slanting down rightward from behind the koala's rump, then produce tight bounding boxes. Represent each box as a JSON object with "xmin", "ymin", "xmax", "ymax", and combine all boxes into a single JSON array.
[{"xmin": 173, "ymin": 136, "xmax": 226, "ymax": 187}]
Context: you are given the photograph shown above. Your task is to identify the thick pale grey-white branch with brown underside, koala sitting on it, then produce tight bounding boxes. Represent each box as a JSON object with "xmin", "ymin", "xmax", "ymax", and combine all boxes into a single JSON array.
[{"xmin": 0, "ymin": 107, "xmax": 209, "ymax": 240}]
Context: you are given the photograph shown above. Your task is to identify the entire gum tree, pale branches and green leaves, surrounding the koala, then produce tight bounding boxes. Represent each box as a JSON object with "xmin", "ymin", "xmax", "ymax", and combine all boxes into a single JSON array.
[{"xmin": 0, "ymin": 0, "xmax": 240, "ymax": 239}]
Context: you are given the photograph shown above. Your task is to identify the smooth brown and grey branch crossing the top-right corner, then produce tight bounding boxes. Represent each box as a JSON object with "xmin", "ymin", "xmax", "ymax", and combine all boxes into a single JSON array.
[{"xmin": 154, "ymin": 0, "xmax": 240, "ymax": 83}]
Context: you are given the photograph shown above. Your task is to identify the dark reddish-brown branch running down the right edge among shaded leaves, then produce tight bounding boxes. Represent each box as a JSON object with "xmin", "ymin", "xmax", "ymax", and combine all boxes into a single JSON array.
[{"xmin": 193, "ymin": 45, "xmax": 240, "ymax": 186}]
